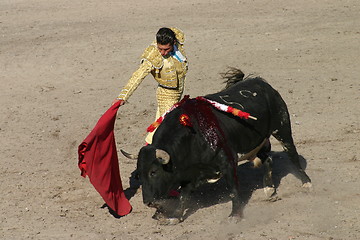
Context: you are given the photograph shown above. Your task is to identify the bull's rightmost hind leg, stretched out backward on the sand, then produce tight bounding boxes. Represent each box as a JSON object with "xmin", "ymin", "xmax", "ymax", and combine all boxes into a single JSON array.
[{"xmin": 273, "ymin": 125, "xmax": 311, "ymax": 187}]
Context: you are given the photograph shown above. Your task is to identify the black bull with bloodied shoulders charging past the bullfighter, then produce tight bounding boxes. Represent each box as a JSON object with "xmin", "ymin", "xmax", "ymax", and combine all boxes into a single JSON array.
[{"xmin": 137, "ymin": 71, "xmax": 311, "ymax": 221}]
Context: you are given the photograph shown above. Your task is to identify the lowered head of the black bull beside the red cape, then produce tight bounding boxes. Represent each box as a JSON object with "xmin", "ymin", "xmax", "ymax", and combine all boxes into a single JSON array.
[{"xmin": 137, "ymin": 145, "xmax": 174, "ymax": 208}]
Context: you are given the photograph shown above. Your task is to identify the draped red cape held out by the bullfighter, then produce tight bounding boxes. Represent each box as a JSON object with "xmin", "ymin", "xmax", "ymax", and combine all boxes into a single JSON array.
[{"xmin": 78, "ymin": 102, "xmax": 132, "ymax": 216}]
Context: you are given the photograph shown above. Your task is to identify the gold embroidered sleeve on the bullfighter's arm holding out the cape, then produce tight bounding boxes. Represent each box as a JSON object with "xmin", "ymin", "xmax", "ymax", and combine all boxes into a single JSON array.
[{"xmin": 117, "ymin": 60, "xmax": 153, "ymax": 101}]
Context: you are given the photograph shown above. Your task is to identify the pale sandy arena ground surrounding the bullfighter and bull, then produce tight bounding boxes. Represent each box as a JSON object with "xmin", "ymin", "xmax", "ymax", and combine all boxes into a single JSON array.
[{"xmin": 0, "ymin": 0, "xmax": 360, "ymax": 240}]
